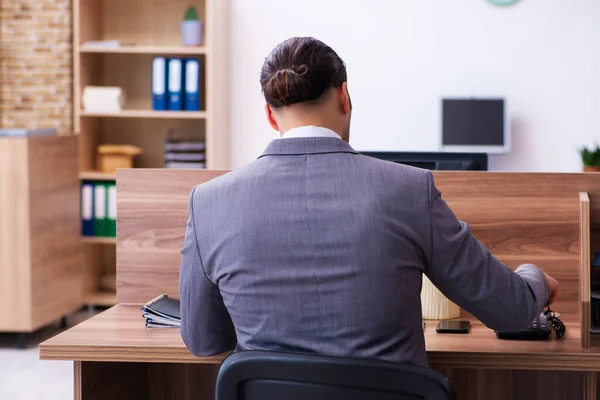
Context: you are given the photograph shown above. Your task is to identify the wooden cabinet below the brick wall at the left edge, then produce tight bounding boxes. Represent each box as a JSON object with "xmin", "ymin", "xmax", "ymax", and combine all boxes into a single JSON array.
[{"xmin": 0, "ymin": 136, "xmax": 82, "ymax": 332}]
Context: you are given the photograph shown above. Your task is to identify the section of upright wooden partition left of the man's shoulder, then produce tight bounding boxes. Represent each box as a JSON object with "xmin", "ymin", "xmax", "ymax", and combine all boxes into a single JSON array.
[{"xmin": 117, "ymin": 169, "xmax": 227, "ymax": 304}]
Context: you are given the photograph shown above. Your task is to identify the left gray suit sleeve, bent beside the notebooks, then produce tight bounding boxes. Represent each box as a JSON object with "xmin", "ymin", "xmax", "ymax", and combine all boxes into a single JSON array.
[{"xmin": 179, "ymin": 188, "xmax": 236, "ymax": 356}]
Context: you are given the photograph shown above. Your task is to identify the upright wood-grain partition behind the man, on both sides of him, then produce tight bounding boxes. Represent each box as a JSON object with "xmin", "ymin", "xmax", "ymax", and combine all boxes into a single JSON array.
[{"xmin": 117, "ymin": 169, "xmax": 600, "ymax": 312}]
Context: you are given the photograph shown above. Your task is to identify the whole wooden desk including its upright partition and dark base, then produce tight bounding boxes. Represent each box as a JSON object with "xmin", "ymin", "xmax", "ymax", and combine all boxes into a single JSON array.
[{"xmin": 40, "ymin": 170, "xmax": 600, "ymax": 400}]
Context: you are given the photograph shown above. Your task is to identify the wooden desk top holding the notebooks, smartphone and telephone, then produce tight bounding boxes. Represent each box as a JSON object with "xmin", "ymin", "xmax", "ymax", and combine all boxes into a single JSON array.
[{"xmin": 40, "ymin": 305, "xmax": 600, "ymax": 371}]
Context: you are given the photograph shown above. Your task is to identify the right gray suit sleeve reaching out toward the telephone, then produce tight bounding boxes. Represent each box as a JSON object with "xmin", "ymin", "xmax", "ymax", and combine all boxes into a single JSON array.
[{"xmin": 425, "ymin": 173, "xmax": 550, "ymax": 331}]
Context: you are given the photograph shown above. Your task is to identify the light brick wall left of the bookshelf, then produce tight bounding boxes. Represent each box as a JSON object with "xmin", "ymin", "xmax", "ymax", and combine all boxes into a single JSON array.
[{"xmin": 0, "ymin": 0, "xmax": 73, "ymax": 134}]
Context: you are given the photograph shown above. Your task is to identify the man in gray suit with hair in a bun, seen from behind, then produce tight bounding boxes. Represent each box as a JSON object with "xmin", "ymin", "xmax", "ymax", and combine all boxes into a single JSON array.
[{"xmin": 179, "ymin": 38, "xmax": 558, "ymax": 366}]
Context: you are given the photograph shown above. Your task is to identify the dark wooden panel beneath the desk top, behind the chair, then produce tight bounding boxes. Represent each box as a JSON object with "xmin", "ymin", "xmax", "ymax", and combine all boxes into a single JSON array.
[{"xmin": 75, "ymin": 361, "xmax": 584, "ymax": 400}]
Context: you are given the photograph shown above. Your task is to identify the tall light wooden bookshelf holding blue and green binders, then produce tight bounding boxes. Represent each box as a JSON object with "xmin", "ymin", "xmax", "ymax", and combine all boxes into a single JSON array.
[{"xmin": 73, "ymin": 0, "xmax": 229, "ymax": 306}]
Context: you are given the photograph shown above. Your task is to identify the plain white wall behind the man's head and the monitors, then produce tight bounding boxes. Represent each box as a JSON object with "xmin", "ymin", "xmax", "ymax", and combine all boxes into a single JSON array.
[{"xmin": 231, "ymin": 0, "xmax": 600, "ymax": 171}]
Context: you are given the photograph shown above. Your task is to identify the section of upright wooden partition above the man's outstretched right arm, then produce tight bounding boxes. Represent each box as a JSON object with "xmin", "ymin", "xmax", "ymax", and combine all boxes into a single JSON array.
[{"xmin": 435, "ymin": 180, "xmax": 581, "ymax": 321}]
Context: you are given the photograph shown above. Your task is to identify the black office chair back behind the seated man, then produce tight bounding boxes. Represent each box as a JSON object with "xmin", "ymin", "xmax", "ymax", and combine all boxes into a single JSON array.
[{"xmin": 215, "ymin": 351, "xmax": 455, "ymax": 400}]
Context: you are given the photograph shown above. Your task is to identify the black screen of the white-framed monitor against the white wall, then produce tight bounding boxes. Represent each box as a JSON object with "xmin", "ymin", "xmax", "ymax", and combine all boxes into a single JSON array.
[{"xmin": 442, "ymin": 99, "xmax": 505, "ymax": 146}]
